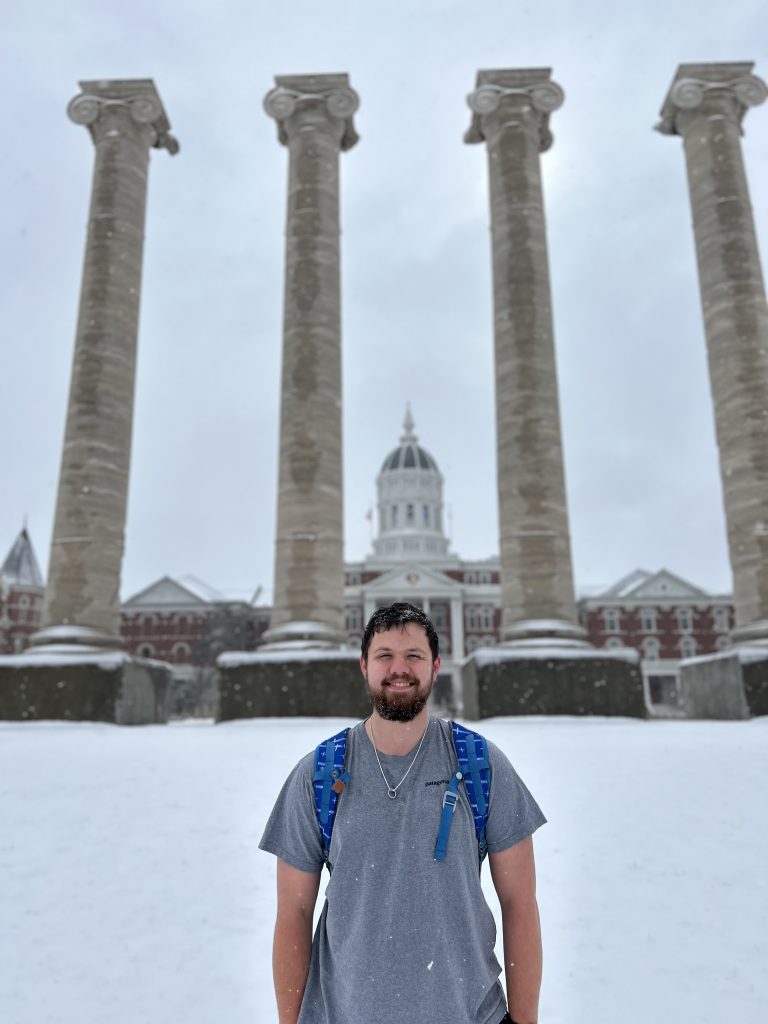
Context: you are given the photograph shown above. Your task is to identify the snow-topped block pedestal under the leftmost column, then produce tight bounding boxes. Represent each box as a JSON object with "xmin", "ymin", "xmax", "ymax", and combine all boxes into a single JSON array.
[{"xmin": 0, "ymin": 644, "xmax": 171, "ymax": 725}]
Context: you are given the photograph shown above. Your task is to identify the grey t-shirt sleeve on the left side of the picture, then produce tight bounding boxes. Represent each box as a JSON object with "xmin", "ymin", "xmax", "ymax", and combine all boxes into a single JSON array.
[{"xmin": 259, "ymin": 754, "xmax": 324, "ymax": 872}]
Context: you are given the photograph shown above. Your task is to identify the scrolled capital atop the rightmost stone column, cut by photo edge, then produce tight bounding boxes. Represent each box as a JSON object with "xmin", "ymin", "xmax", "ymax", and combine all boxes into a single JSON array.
[{"xmin": 655, "ymin": 62, "xmax": 768, "ymax": 135}]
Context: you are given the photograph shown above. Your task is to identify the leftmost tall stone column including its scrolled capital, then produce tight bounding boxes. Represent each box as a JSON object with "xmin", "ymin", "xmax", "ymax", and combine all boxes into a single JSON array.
[{"xmin": 33, "ymin": 79, "xmax": 178, "ymax": 648}]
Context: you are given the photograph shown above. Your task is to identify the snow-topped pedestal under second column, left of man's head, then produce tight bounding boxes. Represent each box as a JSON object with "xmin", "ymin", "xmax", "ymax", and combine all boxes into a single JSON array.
[{"xmin": 217, "ymin": 647, "xmax": 371, "ymax": 722}]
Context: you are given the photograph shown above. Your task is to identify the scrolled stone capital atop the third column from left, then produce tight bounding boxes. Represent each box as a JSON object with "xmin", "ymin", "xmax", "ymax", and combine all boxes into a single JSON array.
[{"xmin": 464, "ymin": 68, "xmax": 565, "ymax": 153}]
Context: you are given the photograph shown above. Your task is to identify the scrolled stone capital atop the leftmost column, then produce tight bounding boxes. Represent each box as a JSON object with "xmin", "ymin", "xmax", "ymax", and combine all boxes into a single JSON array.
[{"xmin": 67, "ymin": 79, "xmax": 179, "ymax": 156}]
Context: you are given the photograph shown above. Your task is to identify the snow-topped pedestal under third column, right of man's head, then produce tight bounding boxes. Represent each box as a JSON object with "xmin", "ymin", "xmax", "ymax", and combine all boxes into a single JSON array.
[{"xmin": 462, "ymin": 645, "xmax": 648, "ymax": 719}]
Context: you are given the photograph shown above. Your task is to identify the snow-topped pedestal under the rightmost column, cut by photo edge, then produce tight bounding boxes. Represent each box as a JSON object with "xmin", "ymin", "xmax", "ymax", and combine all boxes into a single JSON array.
[{"xmin": 680, "ymin": 645, "xmax": 768, "ymax": 721}]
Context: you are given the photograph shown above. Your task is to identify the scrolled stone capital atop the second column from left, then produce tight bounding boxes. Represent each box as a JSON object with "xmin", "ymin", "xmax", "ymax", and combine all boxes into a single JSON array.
[{"xmin": 264, "ymin": 75, "xmax": 360, "ymax": 150}]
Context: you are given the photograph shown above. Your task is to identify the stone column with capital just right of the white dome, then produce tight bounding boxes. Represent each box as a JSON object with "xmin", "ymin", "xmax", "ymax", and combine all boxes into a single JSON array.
[{"xmin": 465, "ymin": 69, "xmax": 585, "ymax": 645}]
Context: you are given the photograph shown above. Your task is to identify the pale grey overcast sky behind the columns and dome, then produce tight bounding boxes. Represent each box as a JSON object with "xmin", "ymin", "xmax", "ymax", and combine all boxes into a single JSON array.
[{"xmin": 0, "ymin": 0, "xmax": 768, "ymax": 597}]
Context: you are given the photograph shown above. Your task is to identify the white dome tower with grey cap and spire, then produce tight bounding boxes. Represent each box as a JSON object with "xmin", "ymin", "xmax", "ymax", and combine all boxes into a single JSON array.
[{"xmin": 374, "ymin": 407, "xmax": 449, "ymax": 560}]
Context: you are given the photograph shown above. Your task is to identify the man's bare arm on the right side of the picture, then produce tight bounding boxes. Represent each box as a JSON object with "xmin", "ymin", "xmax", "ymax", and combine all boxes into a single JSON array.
[{"xmin": 488, "ymin": 837, "xmax": 542, "ymax": 1024}]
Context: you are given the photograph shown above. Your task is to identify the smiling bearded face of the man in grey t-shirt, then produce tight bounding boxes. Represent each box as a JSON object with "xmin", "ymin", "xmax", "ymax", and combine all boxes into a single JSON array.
[{"xmin": 360, "ymin": 623, "xmax": 440, "ymax": 722}]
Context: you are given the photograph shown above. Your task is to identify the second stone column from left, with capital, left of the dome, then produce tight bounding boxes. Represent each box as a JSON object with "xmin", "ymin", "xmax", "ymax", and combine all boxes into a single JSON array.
[{"xmin": 264, "ymin": 75, "xmax": 358, "ymax": 646}]
